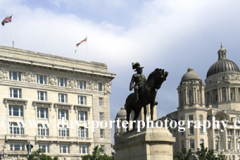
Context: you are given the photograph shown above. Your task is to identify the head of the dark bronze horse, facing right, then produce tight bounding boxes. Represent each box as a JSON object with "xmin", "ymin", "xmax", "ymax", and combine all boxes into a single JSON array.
[{"xmin": 154, "ymin": 68, "xmax": 168, "ymax": 89}]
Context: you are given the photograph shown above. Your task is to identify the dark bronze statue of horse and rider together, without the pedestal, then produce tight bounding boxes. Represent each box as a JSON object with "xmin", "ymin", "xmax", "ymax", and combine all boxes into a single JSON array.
[{"xmin": 125, "ymin": 62, "xmax": 168, "ymax": 131}]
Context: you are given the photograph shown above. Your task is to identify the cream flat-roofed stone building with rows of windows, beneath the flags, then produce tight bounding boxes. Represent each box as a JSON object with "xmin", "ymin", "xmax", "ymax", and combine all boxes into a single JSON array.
[{"xmin": 0, "ymin": 46, "xmax": 116, "ymax": 160}]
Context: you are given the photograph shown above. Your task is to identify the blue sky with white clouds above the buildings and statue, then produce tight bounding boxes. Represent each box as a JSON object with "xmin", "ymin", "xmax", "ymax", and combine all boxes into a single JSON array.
[{"xmin": 0, "ymin": 0, "xmax": 240, "ymax": 144}]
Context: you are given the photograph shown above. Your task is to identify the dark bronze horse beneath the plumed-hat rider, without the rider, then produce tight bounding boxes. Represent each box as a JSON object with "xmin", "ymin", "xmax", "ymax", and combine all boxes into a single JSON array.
[{"xmin": 125, "ymin": 68, "xmax": 168, "ymax": 131}]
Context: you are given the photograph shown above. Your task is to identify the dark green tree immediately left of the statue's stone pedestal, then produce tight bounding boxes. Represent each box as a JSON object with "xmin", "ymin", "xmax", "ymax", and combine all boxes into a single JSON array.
[{"xmin": 81, "ymin": 146, "xmax": 114, "ymax": 160}]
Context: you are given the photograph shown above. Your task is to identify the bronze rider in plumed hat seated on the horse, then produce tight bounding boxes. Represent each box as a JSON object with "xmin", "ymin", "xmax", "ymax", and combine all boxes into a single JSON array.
[{"xmin": 129, "ymin": 62, "xmax": 147, "ymax": 102}]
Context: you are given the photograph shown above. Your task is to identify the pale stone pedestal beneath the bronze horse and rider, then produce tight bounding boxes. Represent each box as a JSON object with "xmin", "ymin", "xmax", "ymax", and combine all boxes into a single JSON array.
[{"xmin": 114, "ymin": 128, "xmax": 175, "ymax": 160}]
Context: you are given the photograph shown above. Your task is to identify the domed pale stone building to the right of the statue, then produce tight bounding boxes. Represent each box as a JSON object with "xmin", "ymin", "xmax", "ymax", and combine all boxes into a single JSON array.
[{"xmin": 167, "ymin": 43, "xmax": 240, "ymax": 160}]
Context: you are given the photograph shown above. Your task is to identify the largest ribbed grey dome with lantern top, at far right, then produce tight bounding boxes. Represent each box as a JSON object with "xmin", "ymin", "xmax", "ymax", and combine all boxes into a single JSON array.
[{"xmin": 207, "ymin": 45, "xmax": 240, "ymax": 77}]
